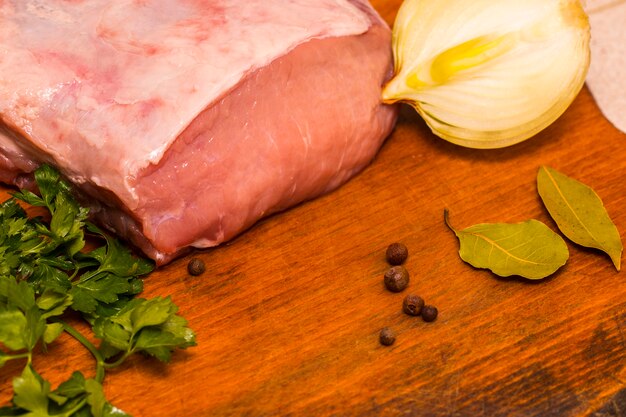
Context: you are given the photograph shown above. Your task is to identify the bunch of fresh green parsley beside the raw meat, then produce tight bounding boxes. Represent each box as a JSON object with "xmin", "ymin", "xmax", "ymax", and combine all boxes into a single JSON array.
[{"xmin": 0, "ymin": 165, "xmax": 195, "ymax": 417}]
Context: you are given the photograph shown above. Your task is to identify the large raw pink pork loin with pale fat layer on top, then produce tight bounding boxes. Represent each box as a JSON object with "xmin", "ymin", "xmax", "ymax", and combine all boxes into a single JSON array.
[{"xmin": 0, "ymin": 0, "xmax": 397, "ymax": 264}]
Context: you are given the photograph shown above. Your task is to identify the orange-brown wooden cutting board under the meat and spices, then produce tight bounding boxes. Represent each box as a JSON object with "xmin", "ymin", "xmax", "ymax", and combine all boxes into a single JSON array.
[{"xmin": 0, "ymin": 0, "xmax": 626, "ymax": 417}]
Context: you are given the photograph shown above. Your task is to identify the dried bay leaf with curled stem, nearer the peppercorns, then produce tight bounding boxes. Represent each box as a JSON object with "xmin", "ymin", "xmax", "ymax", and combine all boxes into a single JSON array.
[{"xmin": 444, "ymin": 210, "xmax": 569, "ymax": 279}]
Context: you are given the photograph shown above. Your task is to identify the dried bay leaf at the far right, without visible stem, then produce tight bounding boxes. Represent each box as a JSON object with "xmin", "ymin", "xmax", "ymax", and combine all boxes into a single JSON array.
[{"xmin": 537, "ymin": 166, "xmax": 623, "ymax": 271}]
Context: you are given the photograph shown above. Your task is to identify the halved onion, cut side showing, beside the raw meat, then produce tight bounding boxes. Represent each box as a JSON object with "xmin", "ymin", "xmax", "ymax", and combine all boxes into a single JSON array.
[{"xmin": 383, "ymin": 0, "xmax": 590, "ymax": 148}]
